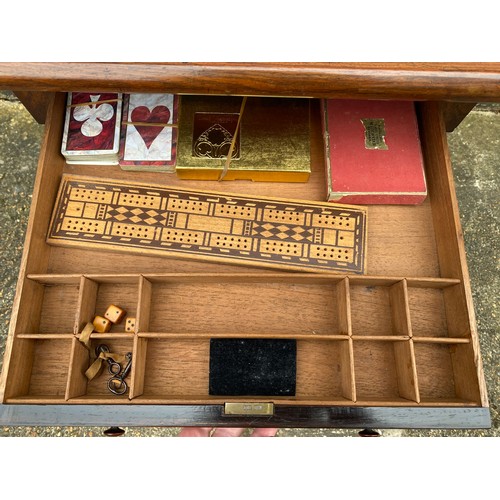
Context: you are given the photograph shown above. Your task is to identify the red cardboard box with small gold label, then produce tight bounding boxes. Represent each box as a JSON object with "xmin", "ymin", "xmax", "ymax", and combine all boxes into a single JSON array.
[{"xmin": 322, "ymin": 99, "xmax": 427, "ymax": 205}]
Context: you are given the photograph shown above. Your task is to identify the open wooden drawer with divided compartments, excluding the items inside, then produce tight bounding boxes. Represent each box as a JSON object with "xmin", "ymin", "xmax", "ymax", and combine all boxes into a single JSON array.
[{"xmin": 0, "ymin": 94, "xmax": 489, "ymax": 427}]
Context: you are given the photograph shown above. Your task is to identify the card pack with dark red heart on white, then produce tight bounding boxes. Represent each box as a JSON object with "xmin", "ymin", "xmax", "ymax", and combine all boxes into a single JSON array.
[{"xmin": 119, "ymin": 94, "xmax": 179, "ymax": 172}]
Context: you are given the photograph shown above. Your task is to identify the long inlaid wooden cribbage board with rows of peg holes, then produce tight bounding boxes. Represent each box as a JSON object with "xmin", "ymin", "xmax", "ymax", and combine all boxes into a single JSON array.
[{"xmin": 47, "ymin": 176, "xmax": 367, "ymax": 274}]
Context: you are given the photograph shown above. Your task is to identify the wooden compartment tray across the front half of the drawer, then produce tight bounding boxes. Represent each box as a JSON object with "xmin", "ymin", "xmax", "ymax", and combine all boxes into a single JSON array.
[{"xmin": 1, "ymin": 273, "xmax": 480, "ymax": 405}]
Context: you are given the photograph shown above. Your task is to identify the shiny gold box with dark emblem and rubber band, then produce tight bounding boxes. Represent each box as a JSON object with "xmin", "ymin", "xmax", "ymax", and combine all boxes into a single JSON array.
[{"xmin": 176, "ymin": 95, "xmax": 311, "ymax": 182}]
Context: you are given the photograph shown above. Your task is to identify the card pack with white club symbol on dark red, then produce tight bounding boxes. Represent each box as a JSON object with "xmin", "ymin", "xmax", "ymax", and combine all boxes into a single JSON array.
[{"xmin": 61, "ymin": 92, "xmax": 122, "ymax": 165}]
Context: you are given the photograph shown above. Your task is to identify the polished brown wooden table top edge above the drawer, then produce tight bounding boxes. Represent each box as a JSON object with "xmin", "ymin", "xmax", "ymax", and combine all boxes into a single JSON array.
[{"xmin": 0, "ymin": 62, "xmax": 500, "ymax": 102}]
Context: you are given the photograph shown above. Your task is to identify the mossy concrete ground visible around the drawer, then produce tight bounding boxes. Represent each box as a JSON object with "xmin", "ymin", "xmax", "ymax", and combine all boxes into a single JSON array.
[{"xmin": 0, "ymin": 92, "xmax": 500, "ymax": 437}]
